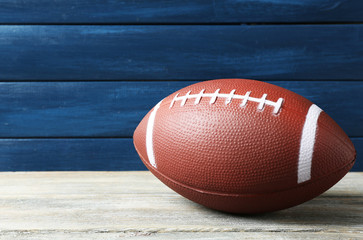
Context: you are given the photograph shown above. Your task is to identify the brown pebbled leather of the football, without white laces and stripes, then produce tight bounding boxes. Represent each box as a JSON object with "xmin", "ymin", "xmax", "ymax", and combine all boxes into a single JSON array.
[{"xmin": 134, "ymin": 79, "xmax": 355, "ymax": 213}]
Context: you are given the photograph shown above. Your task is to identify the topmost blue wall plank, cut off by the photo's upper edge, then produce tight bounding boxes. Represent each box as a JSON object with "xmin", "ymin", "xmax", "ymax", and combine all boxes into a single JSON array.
[{"xmin": 0, "ymin": 0, "xmax": 363, "ymax": 23}]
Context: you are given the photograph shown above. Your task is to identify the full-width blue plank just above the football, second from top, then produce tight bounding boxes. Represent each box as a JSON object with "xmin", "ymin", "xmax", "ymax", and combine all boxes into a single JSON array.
[{"xmin": 0, "ymin": 24, "xmax": 363, "ymax": 81}]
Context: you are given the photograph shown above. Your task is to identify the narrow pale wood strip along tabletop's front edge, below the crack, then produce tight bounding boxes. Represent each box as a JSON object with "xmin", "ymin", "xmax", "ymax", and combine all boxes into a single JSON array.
[{"xmin": 0, "ymin": 229, "xmax": 362, "ymax": 240}]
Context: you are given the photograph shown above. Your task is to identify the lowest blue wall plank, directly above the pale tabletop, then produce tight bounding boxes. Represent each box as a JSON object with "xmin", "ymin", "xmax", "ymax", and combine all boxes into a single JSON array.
[{"xmin": 0, "ymin": 138, "xmax": 363, "ymax": 171}]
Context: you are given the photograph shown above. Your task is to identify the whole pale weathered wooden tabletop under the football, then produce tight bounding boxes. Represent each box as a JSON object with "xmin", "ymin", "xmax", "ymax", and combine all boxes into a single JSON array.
[{"xmin": 0, "ymin": 172, "xmax": 363, "ymax": 240}]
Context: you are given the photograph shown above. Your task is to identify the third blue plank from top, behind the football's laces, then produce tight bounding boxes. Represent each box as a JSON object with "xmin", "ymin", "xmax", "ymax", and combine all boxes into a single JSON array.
[{"xmin": 0, "ymin": 81, "xmax": 363, "ymax": 138}]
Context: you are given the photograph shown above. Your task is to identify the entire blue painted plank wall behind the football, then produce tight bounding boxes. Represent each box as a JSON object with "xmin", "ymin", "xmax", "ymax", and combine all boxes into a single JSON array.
[{"xmin": 0, "ymin": 0, "xmax": 363, "ymax": 171}]
